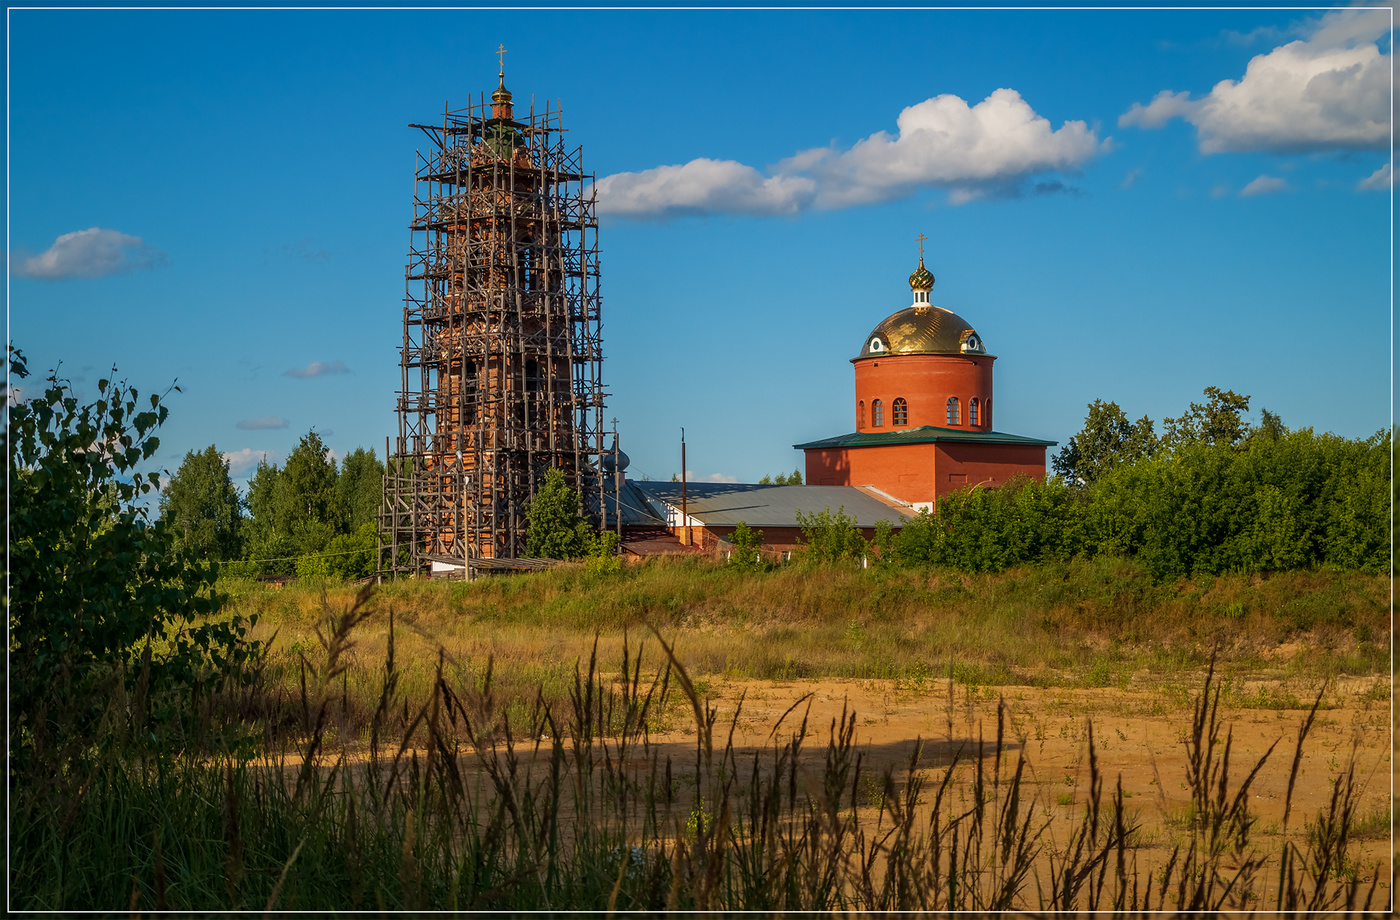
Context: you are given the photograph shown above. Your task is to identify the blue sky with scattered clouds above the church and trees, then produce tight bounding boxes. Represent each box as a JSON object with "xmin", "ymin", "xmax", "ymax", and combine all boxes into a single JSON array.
[{"xmin": 8, "ymin": 7, "xmax": 1392, "ymax": 482}]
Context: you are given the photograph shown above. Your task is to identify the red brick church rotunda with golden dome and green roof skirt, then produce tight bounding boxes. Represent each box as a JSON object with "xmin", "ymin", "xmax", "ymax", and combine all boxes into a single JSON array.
[{"xmin": 794, "ymin": 238, "xmax": 1054, "ymax": 508}]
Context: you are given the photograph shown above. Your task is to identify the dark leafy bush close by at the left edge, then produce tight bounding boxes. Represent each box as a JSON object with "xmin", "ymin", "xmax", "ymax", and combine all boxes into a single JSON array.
[{"xmin": 6, "ymin": 349, "xmax": 255, "ymax": 778}]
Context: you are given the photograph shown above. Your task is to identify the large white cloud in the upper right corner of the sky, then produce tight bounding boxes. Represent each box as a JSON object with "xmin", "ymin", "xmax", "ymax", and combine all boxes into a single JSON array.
[{"xmin": 1119, "ymin": 10, "xmax": 1390, "ymax": 154}]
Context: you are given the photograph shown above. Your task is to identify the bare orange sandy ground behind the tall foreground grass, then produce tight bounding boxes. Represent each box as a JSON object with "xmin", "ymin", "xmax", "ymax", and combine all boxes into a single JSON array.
[{"xmin": 641, "ymin": 679, "xmax": 1393, "ymax": 899}]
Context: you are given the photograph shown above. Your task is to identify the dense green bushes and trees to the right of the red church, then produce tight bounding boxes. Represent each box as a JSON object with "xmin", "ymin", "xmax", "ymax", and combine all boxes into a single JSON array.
[{"xmin": 881, "ymin": 397, "xmax": 1390, "ymax": 581}]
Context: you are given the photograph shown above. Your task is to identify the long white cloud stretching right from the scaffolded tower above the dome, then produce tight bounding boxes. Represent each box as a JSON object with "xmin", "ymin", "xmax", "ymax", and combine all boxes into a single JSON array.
[{"xmin": 596, "ymin": 90, "xmax": 1107, "ymax": 218}]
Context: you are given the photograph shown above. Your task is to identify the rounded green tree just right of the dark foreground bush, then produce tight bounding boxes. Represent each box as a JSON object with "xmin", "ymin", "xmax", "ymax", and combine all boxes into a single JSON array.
[{"xmin": 160, "ymin": 444, "xmax": 244, "ymax": 560}]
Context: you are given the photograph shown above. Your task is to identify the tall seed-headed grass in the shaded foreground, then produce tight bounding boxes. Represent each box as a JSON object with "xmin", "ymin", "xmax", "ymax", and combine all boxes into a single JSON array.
[{"xmin": 11, "ymin": 595, "xmax": 1386, "ymax": 913}]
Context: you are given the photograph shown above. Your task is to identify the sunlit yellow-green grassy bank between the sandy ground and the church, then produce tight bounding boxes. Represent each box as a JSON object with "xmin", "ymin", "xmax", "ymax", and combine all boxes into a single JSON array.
[{"xmin": 221, "ymin": 548, "xmax": 1389, "ymax": 727}]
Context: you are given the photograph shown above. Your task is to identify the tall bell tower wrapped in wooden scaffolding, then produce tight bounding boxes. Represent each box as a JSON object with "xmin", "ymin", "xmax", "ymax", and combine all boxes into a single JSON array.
[{"xmin": 379, "ymin": 74, "xmax": 604, "ymax": 573}]
